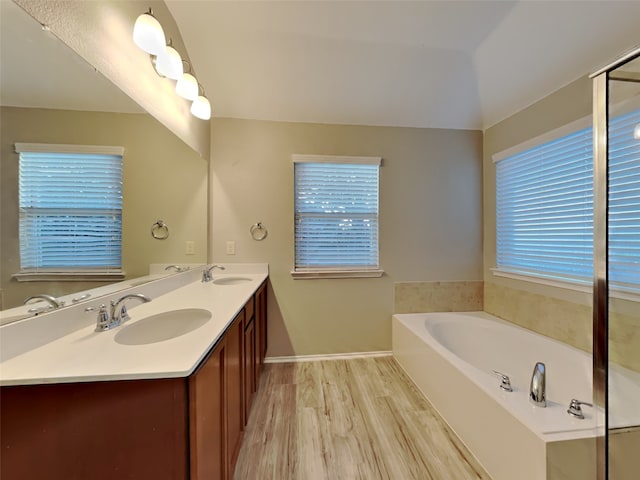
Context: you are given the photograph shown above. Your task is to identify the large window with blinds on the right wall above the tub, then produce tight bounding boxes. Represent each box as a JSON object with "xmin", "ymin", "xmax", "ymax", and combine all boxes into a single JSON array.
[{"xmin": 496, "ymin": 110, "xmax": 640, "ymax": 291}]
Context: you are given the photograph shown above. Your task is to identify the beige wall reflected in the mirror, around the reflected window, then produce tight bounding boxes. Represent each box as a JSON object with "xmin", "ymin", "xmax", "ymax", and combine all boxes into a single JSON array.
[{"xmin": 0, "ymin": 107, "xmax": 208, "ymax": 308}]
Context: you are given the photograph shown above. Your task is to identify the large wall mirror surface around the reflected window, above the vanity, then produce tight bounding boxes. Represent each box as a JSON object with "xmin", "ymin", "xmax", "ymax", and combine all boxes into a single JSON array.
[{"xmin": 0, "ymin": 1, "xmax": 208, "ymax": 316}]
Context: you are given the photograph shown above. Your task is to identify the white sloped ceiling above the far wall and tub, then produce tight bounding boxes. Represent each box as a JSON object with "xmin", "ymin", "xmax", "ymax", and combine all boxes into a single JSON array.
[{"xmin": 165, "ymin": 0, "xmax": 640, "ymax": 129}]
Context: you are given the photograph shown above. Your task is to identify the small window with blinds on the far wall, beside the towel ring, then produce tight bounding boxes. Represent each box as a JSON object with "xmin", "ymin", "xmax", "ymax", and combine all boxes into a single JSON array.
[{"xmin": 293, "ymin": 155, "xmax": 382, "ymax": 278}]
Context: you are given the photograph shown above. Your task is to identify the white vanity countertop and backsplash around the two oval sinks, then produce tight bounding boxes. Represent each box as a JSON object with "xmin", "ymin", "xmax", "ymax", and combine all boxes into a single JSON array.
[{"xmin": 0, "ymin": 264, "xmax": 268, "ymax": 385}]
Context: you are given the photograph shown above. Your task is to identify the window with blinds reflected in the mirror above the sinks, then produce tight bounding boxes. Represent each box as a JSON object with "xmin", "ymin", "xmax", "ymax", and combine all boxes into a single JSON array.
[{"xmin": 16, "ymin": 144, "xmax": 124, "ymax": 280}]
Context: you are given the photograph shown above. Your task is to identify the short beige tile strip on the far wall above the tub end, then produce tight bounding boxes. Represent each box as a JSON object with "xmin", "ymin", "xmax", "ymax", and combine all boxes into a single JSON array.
[{"xmin": 393, "ymin": 281, "xmax": 484, "ymax": 313}]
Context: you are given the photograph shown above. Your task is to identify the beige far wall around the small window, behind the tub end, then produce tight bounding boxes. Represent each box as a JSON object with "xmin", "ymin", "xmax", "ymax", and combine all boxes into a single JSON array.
[{"xmin": 210, "ymin": 119, "xmax": 482, "ymax": 356}]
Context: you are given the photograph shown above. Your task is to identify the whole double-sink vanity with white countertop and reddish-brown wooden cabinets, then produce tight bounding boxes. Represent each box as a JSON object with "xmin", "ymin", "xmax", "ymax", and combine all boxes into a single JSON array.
[{"xmin": 0, "ymin": 270, "xmax": 267, "ymax": 480}]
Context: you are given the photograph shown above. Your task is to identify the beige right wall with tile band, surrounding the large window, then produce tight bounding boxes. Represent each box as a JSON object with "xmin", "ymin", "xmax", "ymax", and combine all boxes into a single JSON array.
[{"xmin": 483, "ymin": 77, "xmax": 640, "ymax": 371}]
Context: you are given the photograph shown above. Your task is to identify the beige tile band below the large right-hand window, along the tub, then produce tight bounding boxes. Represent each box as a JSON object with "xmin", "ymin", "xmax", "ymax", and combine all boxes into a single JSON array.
[{"xmin": 484, "ymin": 282, "xmax": 640, "ymax": 372}]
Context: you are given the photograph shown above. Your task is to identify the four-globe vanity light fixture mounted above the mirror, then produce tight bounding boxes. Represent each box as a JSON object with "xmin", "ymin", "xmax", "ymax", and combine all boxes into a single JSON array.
[{"xmin": 133, "ymin": 8, "xmax": 211, "ymax": 120}]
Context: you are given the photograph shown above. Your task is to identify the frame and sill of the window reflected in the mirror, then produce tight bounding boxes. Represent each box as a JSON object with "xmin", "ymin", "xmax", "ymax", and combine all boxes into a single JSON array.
[{"xmin": 12, "ymin": 143, "xmax": 125, "ymax": 282}]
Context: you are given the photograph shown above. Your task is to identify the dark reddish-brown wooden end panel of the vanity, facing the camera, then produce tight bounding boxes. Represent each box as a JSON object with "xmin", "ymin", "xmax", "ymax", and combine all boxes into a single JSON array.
[{"xmin": 0, "ymin": 378, "xmax": 189, "ymax": 480}]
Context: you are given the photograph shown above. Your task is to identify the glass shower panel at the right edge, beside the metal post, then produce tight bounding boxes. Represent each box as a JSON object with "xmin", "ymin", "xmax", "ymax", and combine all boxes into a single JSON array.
[{"xmin": 606, "ymin": 52, "xmax": 640, "ymax": 480}]
